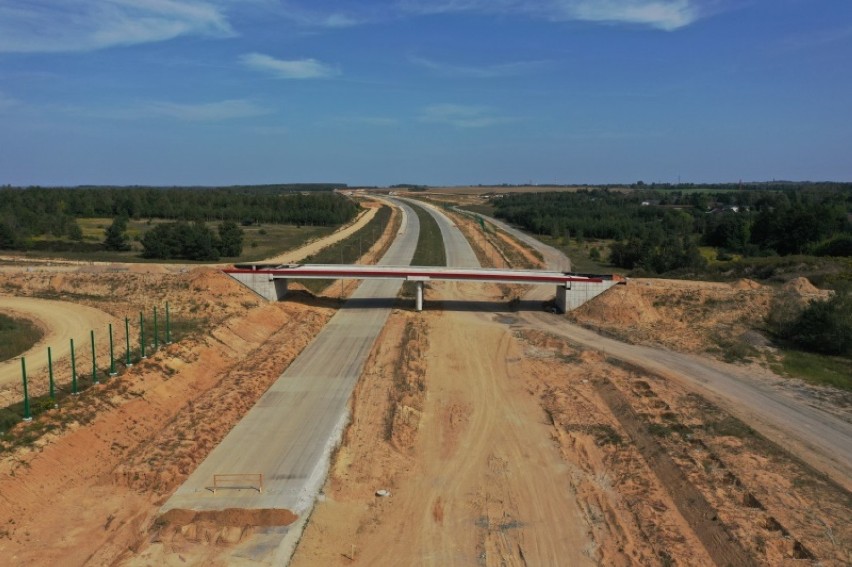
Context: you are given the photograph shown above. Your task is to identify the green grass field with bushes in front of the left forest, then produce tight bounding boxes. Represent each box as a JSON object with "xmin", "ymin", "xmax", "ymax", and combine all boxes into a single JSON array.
[{"xmin": 28, "ymin": 218, "xmax": 337, "ymax": 263}]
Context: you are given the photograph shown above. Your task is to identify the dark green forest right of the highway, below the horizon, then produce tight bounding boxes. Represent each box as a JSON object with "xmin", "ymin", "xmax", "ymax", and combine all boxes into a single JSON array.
[{"xmin": 492, "ymin": 184, "xmax": 852, "ymax": 274}]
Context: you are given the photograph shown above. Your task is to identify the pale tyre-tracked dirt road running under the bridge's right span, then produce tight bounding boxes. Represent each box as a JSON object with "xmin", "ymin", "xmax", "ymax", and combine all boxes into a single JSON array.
[{"xmin": 350, "ymin": 306, "xmax": 592, "ymax": 565}]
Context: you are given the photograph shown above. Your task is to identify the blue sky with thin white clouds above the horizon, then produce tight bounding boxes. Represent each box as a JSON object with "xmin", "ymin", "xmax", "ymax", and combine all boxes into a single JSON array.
[{"xmin": 0, "ymin": 0, "xmax": 852, "ymax": 185}]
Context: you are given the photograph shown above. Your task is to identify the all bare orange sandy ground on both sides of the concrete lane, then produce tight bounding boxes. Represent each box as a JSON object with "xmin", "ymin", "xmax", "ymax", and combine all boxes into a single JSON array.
[{"xmin": 0, "ymin": 203, "xmax": 852, "ymax": 566}]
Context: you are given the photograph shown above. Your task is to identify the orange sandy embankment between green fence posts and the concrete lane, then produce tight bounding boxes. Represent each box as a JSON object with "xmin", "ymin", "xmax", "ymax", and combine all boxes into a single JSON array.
[{"xmin": 0, "ymin": 298, "xmax": 331, "ymax": 565}]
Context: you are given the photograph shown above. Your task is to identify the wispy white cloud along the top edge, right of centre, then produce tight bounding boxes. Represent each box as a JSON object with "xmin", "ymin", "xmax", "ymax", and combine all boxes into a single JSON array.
[{"xmin": 397, "ymin": 0, "xmax": 702, "ymax": 31}]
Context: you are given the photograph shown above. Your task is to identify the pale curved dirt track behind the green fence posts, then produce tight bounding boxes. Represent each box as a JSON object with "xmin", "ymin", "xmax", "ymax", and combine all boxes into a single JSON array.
[{"xmin": 0, "ymin": 295, "xmax": 114, "ymax": 388}]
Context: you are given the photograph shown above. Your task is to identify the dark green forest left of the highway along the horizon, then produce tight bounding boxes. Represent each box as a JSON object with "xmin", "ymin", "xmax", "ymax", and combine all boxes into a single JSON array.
[{"xmin": 0, "ymin": 184, "xmax": 358, "ymax": 251}]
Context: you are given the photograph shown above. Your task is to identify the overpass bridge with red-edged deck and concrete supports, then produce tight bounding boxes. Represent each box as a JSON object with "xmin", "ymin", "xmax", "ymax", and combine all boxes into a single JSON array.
[{"xmin": 223, "ymin": 264, "xmax": 626, "ymax": 312}]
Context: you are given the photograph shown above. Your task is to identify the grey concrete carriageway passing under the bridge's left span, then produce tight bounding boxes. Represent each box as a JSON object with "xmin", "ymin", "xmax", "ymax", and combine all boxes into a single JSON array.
[{"xmin": 161, "ymin": 197, "xmax": 420, "ymax": 516}]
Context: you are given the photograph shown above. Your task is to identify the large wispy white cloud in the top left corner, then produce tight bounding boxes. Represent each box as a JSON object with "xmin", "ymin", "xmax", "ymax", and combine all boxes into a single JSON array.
[{"xmin": 0, "ymin": 0, "xmax": 234, "ymax": 53}]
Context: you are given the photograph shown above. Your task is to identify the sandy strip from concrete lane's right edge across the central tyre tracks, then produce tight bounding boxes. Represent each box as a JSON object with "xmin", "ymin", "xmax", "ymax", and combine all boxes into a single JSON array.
[{"xmin": 293, "ymin": 286, "xmax": 592, "ymax": 565}]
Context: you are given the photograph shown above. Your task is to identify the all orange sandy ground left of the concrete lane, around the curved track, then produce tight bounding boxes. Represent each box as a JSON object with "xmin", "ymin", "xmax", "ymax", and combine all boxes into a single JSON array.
[{"xmin": 0, "ymin": 196, "xmax": 397, "ymax": 566}]
